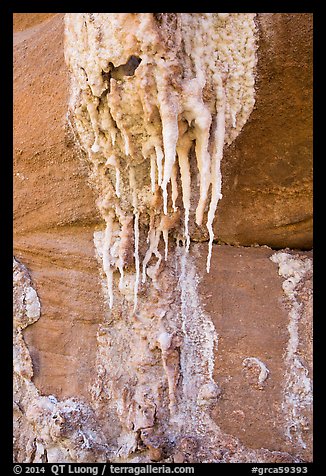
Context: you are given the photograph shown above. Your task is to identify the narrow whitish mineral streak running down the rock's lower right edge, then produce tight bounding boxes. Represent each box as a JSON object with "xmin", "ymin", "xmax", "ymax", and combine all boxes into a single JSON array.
[{"xmin": 270, "ymin": 252, "xmax": 313, "ymax": 448}]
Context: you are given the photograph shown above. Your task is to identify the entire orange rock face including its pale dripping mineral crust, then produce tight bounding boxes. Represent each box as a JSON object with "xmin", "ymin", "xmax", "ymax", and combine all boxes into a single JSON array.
[{"xmin": 13, "ymin": 13, "xmax": 313, "ymax": 463}]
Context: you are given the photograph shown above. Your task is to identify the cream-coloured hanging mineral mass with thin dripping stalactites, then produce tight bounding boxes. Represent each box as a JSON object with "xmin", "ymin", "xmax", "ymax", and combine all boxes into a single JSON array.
[{"xmin": 65, "ymin": 13, "xmax": 256, "ymax": 311}]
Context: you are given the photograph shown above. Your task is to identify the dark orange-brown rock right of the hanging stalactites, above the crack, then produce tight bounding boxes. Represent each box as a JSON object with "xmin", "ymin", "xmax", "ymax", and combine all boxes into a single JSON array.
[{"xmin": 216, "ymin": 13, "xmax": 312, "ymax": 249}]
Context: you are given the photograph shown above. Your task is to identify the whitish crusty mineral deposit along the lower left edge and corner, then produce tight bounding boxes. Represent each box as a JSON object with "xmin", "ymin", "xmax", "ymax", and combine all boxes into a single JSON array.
[{"xmin": 13, "ymin": 258, "xmax": 108, "ymax": 463}]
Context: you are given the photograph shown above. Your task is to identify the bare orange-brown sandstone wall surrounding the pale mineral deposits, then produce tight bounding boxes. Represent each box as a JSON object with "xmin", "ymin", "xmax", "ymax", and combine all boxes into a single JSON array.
[{"xmin": 14, "ymin": 14, "xmax": 312, "ymax": 462}]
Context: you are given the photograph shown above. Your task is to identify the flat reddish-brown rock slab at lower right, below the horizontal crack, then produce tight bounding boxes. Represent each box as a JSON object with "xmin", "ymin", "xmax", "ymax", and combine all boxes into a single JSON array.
[{"xmin": 200, "ymin": 247, "xmax": 312, "ymax": 460}]
